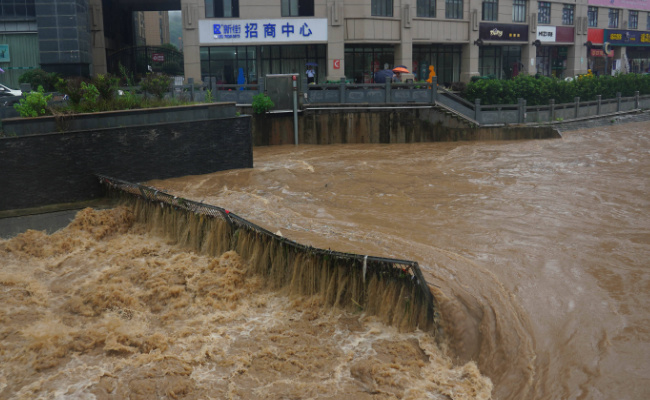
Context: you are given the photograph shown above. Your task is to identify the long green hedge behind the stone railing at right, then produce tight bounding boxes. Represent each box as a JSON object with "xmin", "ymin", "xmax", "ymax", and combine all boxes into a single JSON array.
[{"xmin": 465, "ymin": 74, "xmax": 650, "ymax": 105}]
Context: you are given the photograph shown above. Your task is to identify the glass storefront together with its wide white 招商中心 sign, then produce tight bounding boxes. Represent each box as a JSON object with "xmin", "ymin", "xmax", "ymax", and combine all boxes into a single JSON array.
[{"xmin": 199, "ymin": 18, "xmax": 327, "ymax": 84}]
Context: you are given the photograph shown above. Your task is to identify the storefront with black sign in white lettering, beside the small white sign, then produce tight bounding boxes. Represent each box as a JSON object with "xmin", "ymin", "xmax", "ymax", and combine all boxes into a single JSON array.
[{"xmin": 474, "ymin": 23, "xmax": 528, "ymax": 79}]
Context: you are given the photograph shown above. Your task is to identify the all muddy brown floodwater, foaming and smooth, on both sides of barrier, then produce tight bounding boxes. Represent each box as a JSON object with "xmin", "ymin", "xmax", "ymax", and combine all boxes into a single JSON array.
[{"xmin": 0, "ymin": 122, "xmax": 650, "ymax": 400}]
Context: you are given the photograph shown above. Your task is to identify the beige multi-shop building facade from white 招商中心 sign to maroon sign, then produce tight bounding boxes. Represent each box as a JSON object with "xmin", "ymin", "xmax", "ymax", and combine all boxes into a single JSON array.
[{"xmin": 181, "ymin": 0, "xmax": 596, "ymax": 85}]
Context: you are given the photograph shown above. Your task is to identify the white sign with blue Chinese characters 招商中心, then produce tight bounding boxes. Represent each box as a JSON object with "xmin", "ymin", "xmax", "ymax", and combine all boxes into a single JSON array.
[{"xmin": 199, "ymin": 18, "xmax": 327, "ymax": 45}]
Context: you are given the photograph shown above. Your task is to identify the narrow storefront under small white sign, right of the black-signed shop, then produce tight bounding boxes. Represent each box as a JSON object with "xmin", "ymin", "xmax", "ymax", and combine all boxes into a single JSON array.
[{"xmin": 534, "ymin": 26, "xmax": 574, "ymax": 78}]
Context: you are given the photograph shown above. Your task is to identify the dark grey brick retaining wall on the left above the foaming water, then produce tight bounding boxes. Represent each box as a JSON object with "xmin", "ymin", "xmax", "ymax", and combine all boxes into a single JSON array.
[{"xmin": 0, "ymin": 113, "xmax": 253, "ymax": 211}]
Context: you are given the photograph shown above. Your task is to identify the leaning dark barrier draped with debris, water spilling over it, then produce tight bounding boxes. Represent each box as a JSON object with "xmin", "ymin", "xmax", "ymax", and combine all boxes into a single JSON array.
[{"xmin": 97, "ymin": 175, "xmax": 439, "ymax": 333}]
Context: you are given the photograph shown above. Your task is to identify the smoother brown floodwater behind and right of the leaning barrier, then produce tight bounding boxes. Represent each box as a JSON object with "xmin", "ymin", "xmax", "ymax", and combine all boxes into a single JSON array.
[{"xmin": 148, "ymin": 122, "xmax": 650, "ymax": 399}]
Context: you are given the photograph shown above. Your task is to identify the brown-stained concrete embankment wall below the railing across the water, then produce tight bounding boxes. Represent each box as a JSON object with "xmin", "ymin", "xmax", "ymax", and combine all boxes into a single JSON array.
[{"xmin": 240, "ymin": 105, "xmax": 560, "ymax": 146}]
